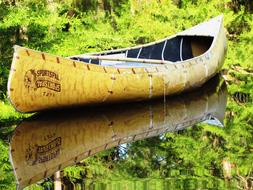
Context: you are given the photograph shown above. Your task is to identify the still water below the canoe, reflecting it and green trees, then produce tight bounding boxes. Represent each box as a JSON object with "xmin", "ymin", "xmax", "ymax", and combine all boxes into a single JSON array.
[{"xmin": 0, "ymin": 75, "xmax": 253, "ymax": 190}]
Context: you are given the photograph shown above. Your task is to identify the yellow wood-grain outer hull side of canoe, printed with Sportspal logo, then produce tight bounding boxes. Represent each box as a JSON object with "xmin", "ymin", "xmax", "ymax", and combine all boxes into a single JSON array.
[{"xmin": 8, "ymin": 15, "xmax": 226, "ymax": 112}]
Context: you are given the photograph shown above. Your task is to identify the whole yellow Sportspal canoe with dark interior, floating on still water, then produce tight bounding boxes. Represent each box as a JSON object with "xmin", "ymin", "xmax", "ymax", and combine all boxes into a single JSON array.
[{"xmin": 8, "ymin": 16, "xmax": 226, "ymax": 112}]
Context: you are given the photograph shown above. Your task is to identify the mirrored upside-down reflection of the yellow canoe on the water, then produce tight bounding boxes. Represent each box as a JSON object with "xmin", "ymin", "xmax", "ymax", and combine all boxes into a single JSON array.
[{"xmin": 10, "ymin": 77, "xmax": 226, "ymax": 187}]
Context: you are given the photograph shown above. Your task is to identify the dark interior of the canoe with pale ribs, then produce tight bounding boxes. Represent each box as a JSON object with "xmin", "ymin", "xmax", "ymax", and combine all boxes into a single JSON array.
[{"xmin": 71, "ymin": 36, "xmax": 213, "ymax": 66}]
